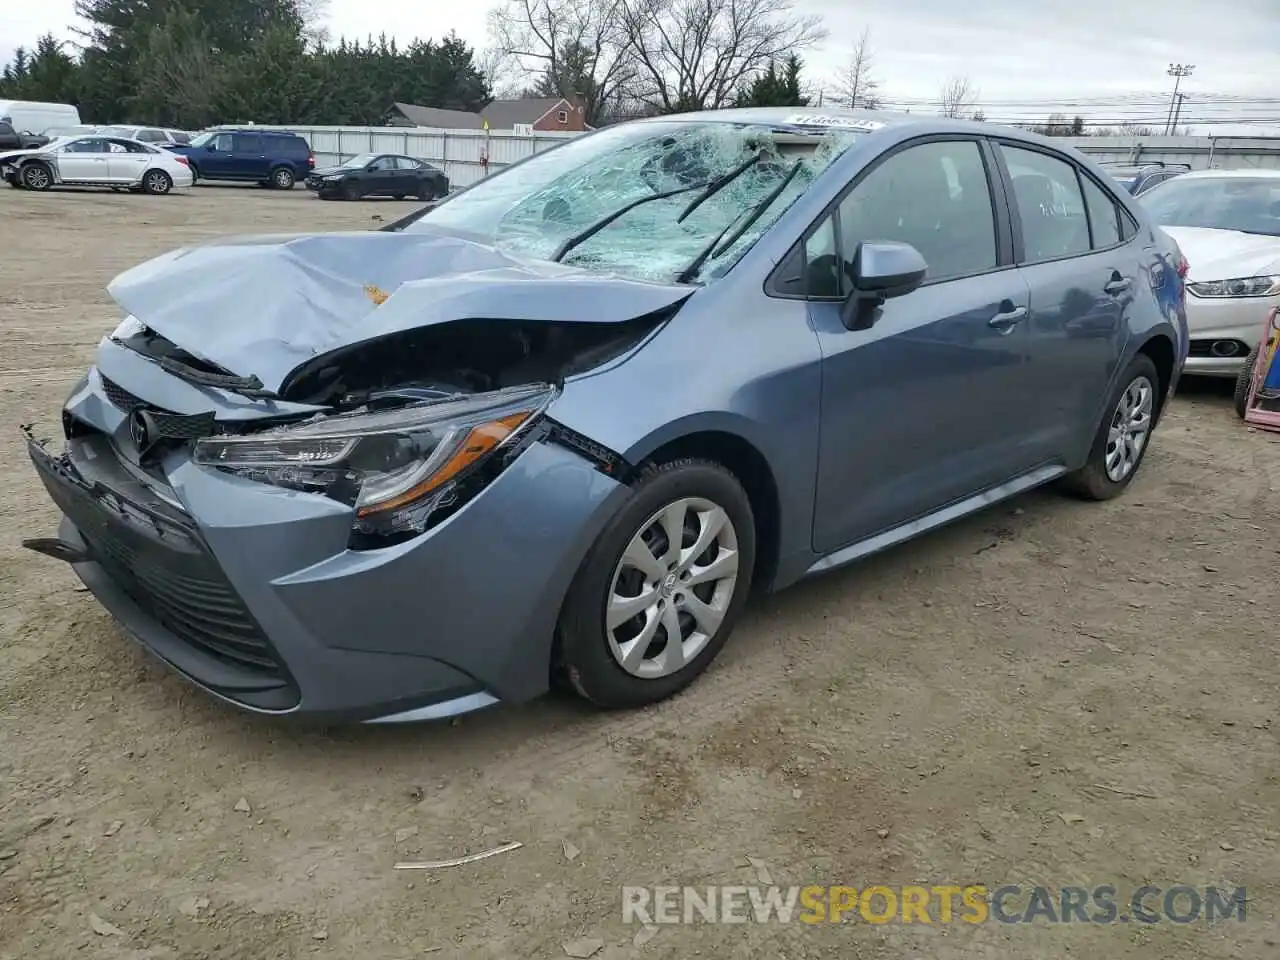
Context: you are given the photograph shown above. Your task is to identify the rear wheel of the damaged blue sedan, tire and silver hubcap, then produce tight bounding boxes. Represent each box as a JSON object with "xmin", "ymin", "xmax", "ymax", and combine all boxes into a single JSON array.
[{"xmin": 1064, "ymin": 353, "xmax": 1161, "ymax": 500}]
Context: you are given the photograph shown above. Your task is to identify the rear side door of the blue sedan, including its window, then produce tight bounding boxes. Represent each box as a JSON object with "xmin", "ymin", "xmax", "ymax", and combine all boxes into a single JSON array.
[{"xmin": 996, "ymin": 142, "xmax": 1143, "ymax": 463}]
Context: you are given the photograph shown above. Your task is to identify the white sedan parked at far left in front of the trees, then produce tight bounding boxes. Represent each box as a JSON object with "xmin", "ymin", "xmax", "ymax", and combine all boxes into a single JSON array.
[{"xmin": 0, "ymin": 134, "xmax": 192, "ymax": 193}]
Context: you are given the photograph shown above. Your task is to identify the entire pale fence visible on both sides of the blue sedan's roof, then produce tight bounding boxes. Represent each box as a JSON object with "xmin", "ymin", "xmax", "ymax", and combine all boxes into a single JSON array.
[{"xmin": 217, "ymin": 127, "xmax": 1280, "ymax": 187}]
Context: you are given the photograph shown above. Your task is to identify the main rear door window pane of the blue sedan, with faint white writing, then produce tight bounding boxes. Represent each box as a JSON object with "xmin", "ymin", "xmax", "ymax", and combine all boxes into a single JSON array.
[{"xmin": 1000, "ymin": 143, "xmax": 1089, "ymax": 262}]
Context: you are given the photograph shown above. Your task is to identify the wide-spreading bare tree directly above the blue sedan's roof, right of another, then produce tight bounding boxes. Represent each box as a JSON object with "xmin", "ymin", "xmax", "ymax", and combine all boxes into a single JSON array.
[{"xmin": 617, "ymin": 0, "xmax": 826, "ymax": 113}]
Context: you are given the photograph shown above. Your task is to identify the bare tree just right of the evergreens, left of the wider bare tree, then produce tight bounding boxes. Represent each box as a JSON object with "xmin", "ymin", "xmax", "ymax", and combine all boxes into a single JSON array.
[{"xmin": 489, "ymin": 0, "xmax": 634, "ymax": 124}]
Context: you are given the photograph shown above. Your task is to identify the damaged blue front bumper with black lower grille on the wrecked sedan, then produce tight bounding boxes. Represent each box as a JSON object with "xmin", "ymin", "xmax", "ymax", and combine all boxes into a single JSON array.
[{"xmin": 29, "ymin": 378, "xmax": 626, "ymax": 721}]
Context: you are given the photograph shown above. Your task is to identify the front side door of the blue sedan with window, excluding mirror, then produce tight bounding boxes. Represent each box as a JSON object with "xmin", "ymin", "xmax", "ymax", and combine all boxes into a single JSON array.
[{"xmin": 805, "ymin": 137, "xmax": 1032, "ymax": 553}]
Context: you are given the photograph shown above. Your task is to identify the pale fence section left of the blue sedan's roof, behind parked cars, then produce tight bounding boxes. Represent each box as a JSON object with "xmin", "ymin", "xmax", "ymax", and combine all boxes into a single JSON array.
[{"xmin": 215, "ymin": 125, "xmax": 577, "ymax": 187}]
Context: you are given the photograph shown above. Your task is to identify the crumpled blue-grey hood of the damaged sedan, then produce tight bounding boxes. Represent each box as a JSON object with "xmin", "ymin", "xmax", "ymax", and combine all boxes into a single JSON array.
[{"xmin": 108, "ymin": 230, "xmax": 692, "ymax": 390}]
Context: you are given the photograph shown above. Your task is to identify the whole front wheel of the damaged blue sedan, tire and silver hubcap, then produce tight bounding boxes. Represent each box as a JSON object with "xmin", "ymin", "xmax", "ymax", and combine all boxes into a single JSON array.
[{"xmin": 557, "ymin": 460, "xmax": 755, "ymax": 708}]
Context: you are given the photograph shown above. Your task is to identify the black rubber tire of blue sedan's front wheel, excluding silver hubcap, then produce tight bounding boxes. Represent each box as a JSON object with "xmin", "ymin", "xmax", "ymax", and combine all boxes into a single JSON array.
[{"xmin": 554, "ymin": 460, "xmax": 755, "ymax": 709}]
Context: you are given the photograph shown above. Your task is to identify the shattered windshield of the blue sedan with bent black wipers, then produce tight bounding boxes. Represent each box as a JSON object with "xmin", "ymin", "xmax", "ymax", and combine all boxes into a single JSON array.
[{"xmin": 406, "ymin": 120, "xmax": 863, "ymax": 282}]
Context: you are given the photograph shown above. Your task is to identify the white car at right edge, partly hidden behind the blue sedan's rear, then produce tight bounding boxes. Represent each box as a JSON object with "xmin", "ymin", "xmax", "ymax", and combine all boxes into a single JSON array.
[{"xmin": 1138, "ymin": 170, "xmax": 1280, "ymax": 378}]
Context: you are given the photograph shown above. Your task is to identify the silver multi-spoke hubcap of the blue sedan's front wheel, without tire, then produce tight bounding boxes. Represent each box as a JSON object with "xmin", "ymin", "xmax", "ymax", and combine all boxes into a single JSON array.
[{"xmin": 604, "ymin": 497, "xmax": 739, "ymax": 680}]
